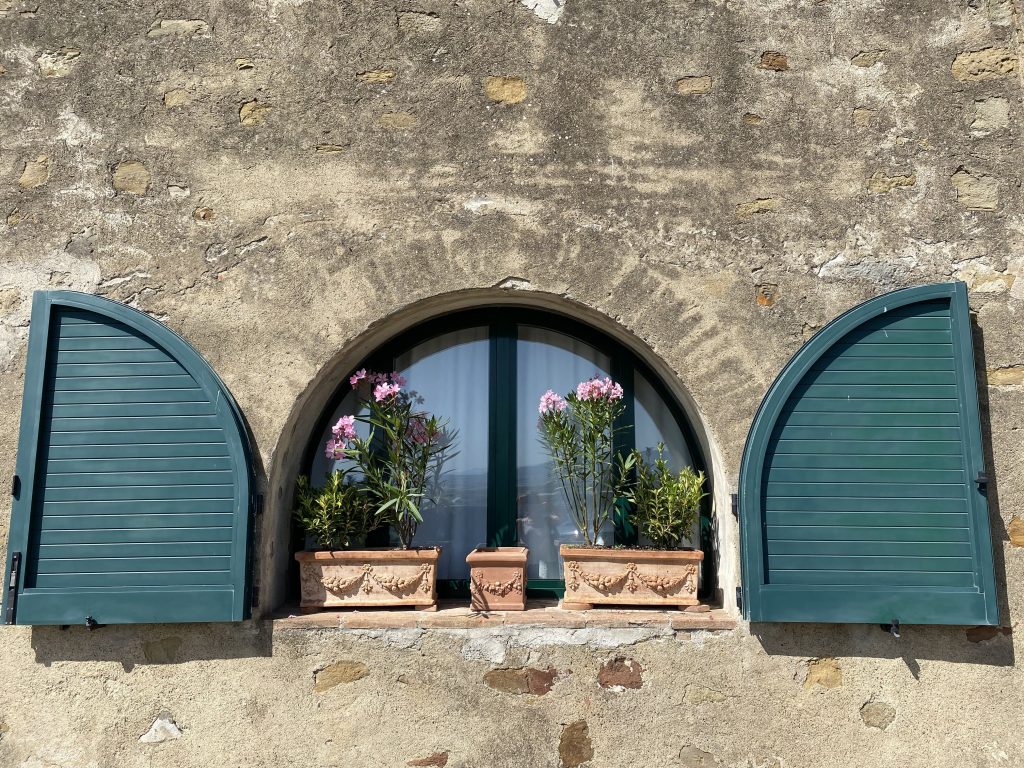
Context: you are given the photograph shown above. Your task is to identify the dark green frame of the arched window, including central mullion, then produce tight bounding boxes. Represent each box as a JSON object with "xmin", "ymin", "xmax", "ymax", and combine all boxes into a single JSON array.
[{"xmin": 290, "ymin": 306, "xmax": 718, "ymax": 599}]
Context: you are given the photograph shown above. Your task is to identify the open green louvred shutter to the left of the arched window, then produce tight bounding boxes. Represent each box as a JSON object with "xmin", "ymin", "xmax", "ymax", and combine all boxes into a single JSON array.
[{"xmin": 4, "ymin": 292, "xmax": 254, "ymax": 625}]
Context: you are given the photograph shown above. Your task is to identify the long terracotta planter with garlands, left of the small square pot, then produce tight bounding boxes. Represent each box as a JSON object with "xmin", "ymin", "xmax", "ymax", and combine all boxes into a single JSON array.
[{"xmin": 295, "ymin": 547, "xmax": 441, "ymax": 612}]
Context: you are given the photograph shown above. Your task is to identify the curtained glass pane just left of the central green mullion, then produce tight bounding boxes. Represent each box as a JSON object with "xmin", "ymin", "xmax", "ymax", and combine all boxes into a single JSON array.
[{"xmin": 395, "ymin": 328, "xmax": 489, "ymax": 579}]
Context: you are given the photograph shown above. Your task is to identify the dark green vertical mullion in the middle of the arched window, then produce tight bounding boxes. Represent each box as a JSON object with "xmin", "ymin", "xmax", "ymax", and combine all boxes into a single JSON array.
[{"xmin": 487, "ymin": 322, "xmax": 518, "ymax": 547}]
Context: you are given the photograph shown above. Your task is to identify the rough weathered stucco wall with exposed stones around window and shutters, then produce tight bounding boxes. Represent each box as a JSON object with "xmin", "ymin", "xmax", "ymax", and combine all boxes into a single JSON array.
[{"xmin": 0, "ymin": 0, "xmax": 1024, "ymax": 768}]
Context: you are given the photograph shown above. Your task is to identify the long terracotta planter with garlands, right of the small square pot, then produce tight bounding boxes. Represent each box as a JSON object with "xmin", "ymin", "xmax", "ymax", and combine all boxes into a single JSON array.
[{"xmin": 559, "ymin": 544, "xmax": 703, "ymax": 610}]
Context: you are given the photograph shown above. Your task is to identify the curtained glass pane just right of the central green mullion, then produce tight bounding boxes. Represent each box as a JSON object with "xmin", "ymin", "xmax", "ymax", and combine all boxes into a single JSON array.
[{"xmin": 516, "ymin": 326, "xmax": 612, "ymax": 579}]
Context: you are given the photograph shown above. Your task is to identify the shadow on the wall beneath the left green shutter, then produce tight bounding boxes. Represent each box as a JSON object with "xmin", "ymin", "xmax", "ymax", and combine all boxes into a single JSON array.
[{"xmin": 32, "ymin": 621, "xmax": 273, "ymax": 672}]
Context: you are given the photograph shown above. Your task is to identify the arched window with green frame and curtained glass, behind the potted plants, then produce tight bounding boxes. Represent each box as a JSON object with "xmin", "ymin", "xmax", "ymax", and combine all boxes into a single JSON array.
[{"xmin": 299, "ymin": 307, "xmax": 715, "ymax": 594}]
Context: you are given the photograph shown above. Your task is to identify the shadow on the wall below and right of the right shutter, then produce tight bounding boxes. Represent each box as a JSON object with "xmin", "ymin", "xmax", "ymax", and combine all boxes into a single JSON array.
[{"xmin": 751, "ymin": 315, "xmax": 1014, "ymax": 678}]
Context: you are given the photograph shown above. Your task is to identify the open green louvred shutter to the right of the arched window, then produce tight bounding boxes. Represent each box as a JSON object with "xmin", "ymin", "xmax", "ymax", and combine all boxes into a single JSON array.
[{"xmin": 739, "ymin": 283, "xmax": 998, "ymax": 625}]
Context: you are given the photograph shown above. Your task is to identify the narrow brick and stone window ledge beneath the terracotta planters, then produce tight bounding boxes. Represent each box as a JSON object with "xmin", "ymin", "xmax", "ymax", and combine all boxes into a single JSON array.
[{"xmin": 273, "ymin": 600, "xmax": 736, "ymax": 631}]
